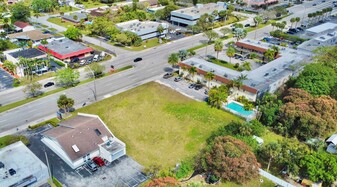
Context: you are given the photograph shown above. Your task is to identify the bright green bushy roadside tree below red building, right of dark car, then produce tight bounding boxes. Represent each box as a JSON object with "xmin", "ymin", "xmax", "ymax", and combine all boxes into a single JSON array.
[{"xmin": 55, "ymin": 68, "xmax": 80, "ymax": 87}]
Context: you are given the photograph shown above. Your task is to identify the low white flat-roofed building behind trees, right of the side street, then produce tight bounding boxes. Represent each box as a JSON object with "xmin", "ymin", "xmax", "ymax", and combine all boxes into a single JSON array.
[{"xmin": 116, "ymin": 20, "xmax": 168, "ymax": 40}]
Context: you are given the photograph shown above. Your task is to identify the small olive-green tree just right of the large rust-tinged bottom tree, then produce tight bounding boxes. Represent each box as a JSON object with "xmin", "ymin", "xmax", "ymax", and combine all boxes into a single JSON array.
[{"xmin": 259, "ymin": 142, "xmax": 281, "ymax": 172}]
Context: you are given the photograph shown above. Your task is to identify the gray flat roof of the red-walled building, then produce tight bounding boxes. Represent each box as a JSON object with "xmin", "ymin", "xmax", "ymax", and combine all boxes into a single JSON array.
[{"xmin": 46, "ymin": 38, "xmax": 88, "ymax": 55}]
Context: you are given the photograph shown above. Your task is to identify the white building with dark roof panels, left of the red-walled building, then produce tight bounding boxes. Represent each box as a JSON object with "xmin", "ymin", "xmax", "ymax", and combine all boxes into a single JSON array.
[{"xmin": 3, "ymin": 48, "xmax": 48, "ymax": 77}]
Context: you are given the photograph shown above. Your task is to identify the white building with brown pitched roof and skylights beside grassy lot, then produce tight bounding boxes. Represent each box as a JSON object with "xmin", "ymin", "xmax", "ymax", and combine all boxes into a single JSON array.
[{"xmin": 41, "ymin": 113, "xmax": 126, "ymax": 169}]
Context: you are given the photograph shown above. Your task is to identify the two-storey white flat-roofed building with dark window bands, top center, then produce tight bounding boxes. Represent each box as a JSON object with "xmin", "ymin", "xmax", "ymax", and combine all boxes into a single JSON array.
[{"xmin": 171, "ymin": 2, "xmax": 227, "ymax": 26}]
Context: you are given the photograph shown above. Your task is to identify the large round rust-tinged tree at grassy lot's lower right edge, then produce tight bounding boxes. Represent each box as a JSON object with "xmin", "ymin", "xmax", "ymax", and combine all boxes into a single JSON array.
[{"xmin": 201, "ymin": 136, "xmax": 260, "ymax": 184}]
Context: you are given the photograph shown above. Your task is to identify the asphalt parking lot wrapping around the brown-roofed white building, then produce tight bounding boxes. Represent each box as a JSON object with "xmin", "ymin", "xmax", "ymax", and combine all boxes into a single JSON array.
[{"xmin": 25, "ymin": 126, "xmax": 147, "ymax": 187}]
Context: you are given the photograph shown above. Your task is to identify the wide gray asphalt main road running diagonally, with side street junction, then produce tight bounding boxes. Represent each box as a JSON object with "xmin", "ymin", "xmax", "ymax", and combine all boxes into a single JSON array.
[{"xmin": 0, "ymin": 1, "xmax": 332, "ymax": 136}]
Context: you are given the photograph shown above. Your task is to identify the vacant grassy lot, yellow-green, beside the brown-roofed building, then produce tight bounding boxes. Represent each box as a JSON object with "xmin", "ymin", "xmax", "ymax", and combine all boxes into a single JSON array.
[{"xmin": 78, "ymin": 83, "xmax": 239, "ymax": 168}]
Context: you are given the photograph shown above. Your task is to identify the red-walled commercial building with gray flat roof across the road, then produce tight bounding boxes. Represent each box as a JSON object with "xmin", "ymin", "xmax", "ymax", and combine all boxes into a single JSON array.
[{"xmin": 39, "ymin": 37, "xmax": 93, "ymax": 61}]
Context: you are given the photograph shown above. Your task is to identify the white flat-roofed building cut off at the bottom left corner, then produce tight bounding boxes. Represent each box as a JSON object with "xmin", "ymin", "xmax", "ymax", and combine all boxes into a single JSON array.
[{"xmin": 0, "ymin": 141, "xmax": 49, "ymax": 187}]
